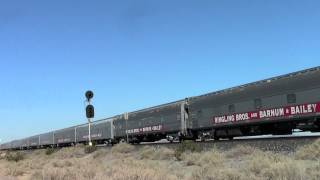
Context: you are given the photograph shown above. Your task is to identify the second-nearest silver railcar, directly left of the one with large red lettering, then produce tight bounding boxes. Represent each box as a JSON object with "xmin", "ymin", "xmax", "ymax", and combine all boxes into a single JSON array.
[{"xmin": 114, "ymin": 100, "xmax": 187, "ymax": 143}]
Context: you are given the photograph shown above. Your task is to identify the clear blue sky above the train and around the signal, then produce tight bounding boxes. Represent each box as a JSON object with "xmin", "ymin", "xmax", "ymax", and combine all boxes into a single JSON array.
[{"xmin": 0, "ymin": 0, "xmax": 320, "ymax": 142}]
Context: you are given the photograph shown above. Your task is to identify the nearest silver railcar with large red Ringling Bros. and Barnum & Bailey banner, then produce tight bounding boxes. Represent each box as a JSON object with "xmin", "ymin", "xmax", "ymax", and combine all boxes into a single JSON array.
[{"xmin": 189, "ymin": 67, "xmax": 320, "ymax": 139}]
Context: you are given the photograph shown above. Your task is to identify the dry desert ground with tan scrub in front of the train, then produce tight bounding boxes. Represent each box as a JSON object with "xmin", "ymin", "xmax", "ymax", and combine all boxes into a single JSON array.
[{"xmin": 0, "ymin": 140, "xmax": 320, "ymax": 180}]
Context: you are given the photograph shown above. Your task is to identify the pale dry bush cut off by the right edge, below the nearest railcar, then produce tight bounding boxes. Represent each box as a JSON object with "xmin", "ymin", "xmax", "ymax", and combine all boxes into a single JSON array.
[{"xmin": 295, "ymin": 139, "xmax": 320, "ymax": 160}]
